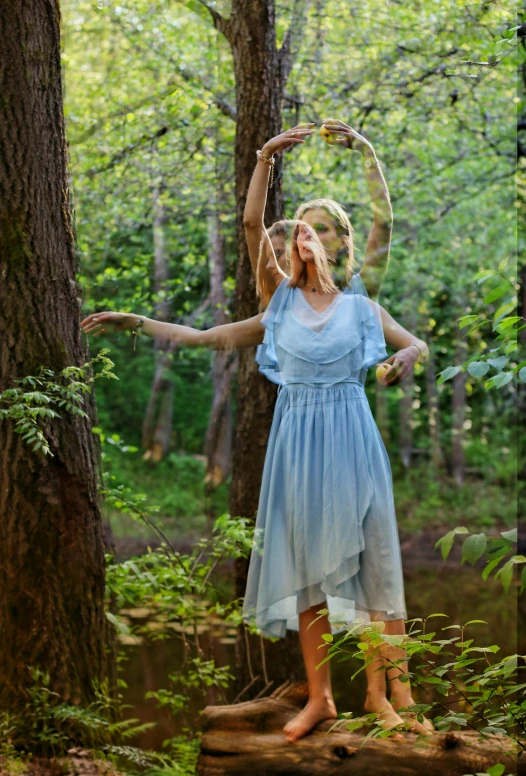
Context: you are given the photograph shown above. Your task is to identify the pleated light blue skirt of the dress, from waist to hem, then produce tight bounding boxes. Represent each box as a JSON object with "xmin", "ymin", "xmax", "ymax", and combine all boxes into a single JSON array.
[{"xmin": 243, "ymin": 380, "xmax": 406, "ymax": 637}]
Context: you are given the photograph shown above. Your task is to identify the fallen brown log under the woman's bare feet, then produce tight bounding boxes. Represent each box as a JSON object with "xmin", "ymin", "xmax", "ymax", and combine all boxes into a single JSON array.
[{"xmin": 197, "ymin": 683, "xmax": 526, "ymax": 776}]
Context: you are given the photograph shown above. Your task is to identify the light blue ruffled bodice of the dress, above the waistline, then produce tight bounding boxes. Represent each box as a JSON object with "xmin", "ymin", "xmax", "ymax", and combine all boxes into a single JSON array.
[{"xmin": 256, "ymin": 275, "xmax": 387, "ymax": 387}]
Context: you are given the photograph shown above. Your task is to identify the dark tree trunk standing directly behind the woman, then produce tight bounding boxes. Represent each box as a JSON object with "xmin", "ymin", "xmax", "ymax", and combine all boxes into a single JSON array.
[{"xmin": 208, "ymin": 0, "xmax": 306, "ymax": 694}]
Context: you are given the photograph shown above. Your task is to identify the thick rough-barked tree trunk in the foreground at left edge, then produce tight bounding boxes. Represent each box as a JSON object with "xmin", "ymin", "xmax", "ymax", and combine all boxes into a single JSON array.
[{"xmin": 0, "ymin": 0, "xmax": 106, "ymax": 712}]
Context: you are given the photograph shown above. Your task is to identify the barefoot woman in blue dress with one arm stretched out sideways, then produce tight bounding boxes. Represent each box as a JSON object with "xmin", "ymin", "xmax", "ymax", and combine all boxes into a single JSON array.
[{"xmin": 82, "ymin": 224, "xmax": 434, "ymax": 741}]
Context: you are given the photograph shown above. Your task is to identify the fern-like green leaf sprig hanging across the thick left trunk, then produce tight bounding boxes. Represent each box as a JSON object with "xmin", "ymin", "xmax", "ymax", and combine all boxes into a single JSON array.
[{"xmin": 0, "ymin": 350, "xmax": 118, "ymax": 456}]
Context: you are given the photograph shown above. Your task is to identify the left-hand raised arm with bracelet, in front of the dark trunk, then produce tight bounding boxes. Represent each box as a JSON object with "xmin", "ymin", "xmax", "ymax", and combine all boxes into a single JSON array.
[{"xmin": 243, "ymin": 124, "xmax": 314, "ymax": 285}]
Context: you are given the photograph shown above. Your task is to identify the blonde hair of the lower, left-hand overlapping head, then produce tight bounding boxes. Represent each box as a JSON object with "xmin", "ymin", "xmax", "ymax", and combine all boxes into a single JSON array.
[{"xmin": 256, "ymin": 219, "xmax": 338, "ymax": 308}]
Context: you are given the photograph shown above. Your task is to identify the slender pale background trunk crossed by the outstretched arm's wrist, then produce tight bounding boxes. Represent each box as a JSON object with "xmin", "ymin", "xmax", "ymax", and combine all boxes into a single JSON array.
[{"xmin": 142, "ymin": 180, "xmax": 174, "ymax": 463}]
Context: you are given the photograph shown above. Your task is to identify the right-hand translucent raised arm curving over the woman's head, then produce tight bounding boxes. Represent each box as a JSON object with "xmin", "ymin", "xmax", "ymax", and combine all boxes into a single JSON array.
[{"xmin": 323, "ymin": 119, "xmax": 393, "ymax": 299}]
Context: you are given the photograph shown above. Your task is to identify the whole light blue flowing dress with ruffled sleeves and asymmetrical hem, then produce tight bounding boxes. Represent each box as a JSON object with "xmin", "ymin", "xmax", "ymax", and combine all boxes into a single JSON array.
[{"xmin": 243, "ymin": 275, "xmax": 407, "ymax": 637}]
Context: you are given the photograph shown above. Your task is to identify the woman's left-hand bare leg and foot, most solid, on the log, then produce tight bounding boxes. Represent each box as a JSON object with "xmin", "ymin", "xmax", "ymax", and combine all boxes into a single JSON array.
[{"xmin": 283, "ymin": 603, "xmax": 337, "ymax": 741}]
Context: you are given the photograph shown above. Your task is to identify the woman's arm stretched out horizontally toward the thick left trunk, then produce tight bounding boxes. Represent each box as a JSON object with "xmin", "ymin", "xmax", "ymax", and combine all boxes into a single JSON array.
[{"xmin": 81, "ymin": 312, "xmax": 264, "ymax": 350}]
